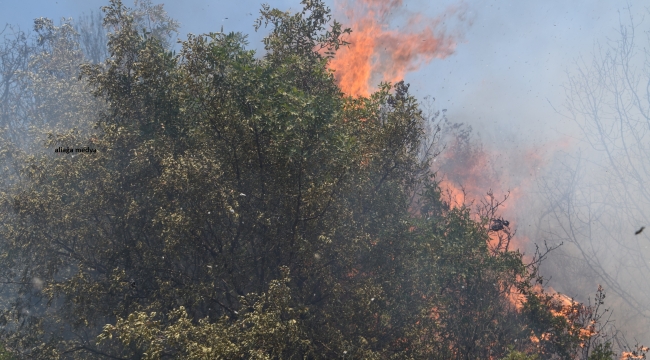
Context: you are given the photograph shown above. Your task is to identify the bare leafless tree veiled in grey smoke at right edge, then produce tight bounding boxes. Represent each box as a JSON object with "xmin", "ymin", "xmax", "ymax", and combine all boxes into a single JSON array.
[{"xmin": 540, "ymin": 4, "xmax": 650, "ymax": 342}]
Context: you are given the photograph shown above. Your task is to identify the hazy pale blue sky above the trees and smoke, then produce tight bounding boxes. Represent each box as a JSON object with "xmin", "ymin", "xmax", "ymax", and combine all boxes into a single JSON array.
[{"xmin": 0, "ymin": 0, "xmax": 650, "ymax": 340}]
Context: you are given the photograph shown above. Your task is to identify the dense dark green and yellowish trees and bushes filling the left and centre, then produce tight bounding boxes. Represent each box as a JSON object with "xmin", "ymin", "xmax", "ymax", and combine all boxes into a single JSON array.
[{"xmin": 0, "ymin": 0, "xmax": 632, "ymax": 359}]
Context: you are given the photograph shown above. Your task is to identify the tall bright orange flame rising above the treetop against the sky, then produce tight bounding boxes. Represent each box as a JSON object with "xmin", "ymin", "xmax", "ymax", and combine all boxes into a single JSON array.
[{"xmin": 329, "ymin": 0, "xmax": 466, "ymax": 96}]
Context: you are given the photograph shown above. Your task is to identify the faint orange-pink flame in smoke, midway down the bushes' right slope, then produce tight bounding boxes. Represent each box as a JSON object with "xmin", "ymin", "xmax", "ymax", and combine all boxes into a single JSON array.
[{"xmin": 433, "ymin": 134, "xmax": 570, "ymax": 251}]
